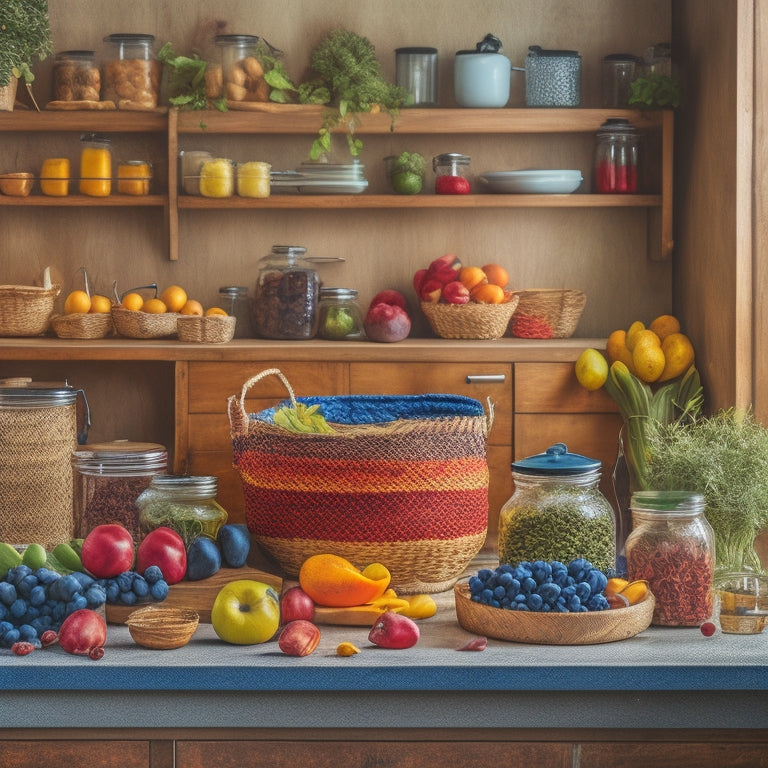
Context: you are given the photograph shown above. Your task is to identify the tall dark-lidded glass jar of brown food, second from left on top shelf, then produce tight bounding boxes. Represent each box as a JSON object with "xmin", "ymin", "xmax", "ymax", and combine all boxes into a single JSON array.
[{"xmin": 101, "ymin": 33, "xmax": 163, "ymax": 109}]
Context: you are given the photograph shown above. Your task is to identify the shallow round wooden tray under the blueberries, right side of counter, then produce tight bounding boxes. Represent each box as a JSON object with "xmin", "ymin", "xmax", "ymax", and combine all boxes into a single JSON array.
[{"xmin": 454, "ymin": 583, "xmax": 656, "ymax": 645}]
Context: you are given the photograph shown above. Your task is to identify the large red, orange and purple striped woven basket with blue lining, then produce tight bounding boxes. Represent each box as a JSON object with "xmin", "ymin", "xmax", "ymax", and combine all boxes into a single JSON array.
[{"xmin": 228, "ymin": 369, "xmax": 492, "ymax": 593}]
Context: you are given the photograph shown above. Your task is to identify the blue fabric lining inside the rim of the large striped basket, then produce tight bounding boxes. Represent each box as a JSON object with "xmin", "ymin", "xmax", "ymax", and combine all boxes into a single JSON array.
[{"xmin": 251, "ymin": 395, "xmax": 485, "ymax": 424}]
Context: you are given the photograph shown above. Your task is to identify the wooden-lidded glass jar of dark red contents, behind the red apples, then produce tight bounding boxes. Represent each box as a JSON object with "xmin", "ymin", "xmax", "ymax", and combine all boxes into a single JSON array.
[{"xmin": 72, "ymin": 440, "xmax": 168, "ymax": 541}]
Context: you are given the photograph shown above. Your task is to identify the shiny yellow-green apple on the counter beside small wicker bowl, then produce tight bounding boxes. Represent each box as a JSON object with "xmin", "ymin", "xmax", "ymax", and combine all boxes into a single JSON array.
[{"xmin": 211, "ymin": 579, "xmax": 280, "ymax": 645}]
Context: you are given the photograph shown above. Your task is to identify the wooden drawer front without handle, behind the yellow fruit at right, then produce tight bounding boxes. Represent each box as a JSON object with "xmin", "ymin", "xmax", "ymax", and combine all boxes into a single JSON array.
[{"xmin": 515, "ymin": 363, "xmax": 618, "ymax": 413}]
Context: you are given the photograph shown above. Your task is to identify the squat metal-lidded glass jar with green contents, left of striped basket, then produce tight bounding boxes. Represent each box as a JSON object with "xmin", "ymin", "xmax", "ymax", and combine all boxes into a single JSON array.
[{"xmin": 136, "ymin": 475, "xmax": 227, "ymax": 546}]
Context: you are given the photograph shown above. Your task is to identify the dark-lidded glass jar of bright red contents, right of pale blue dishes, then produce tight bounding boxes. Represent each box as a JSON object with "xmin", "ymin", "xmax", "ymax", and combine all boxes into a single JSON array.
[{"xmin": 595, "ymin": 118, "xmax": 640, "ymax": 194}]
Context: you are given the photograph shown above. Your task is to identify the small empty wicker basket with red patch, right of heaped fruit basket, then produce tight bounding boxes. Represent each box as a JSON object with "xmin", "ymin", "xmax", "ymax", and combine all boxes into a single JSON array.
[{"xmin": 509, "ymin": 288, "xmax": 587, "ymax": 339}]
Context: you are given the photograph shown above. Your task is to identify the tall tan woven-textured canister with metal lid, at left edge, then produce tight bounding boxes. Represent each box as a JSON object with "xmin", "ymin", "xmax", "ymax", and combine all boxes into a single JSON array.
[{"xmin": 0, "ymin": 378, "xmax": 90, "ymax": 549}]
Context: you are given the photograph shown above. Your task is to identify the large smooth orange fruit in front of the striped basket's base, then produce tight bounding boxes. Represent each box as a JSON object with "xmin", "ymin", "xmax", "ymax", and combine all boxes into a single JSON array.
[{"xmin": 299, "ymin": 554, "xmax": 390, "ymax": 608}]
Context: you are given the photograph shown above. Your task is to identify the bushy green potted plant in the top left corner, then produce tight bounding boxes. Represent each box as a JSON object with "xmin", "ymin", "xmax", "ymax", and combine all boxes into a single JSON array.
[{"xmin": 0, "ymin": 0, "xmax": 53, "ymax": 111}]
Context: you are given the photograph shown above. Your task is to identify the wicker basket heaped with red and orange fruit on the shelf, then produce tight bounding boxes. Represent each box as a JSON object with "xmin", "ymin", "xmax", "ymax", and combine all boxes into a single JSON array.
[{"xmin": 414, "ymin": 254, "xmax": 518, "ymax": 339}]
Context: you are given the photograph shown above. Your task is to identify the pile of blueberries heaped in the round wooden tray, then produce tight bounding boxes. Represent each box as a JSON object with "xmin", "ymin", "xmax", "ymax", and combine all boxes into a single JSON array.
[{"xmin": 469, "ymin": 557, "xmax": 610, "ymax": 613}]
